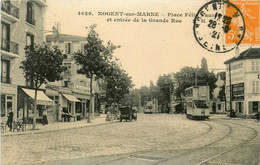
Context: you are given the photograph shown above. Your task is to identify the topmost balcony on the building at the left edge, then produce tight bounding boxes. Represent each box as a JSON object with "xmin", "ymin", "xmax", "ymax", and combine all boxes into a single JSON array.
[{"xmin": 1, "ymin": 1, "xmax": 20, "ymax": 22}]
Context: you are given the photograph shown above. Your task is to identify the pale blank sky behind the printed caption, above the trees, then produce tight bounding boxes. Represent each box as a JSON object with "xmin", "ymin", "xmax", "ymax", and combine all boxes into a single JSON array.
[{"xmin": 45, "ymin": 0, "xmax": 254, "ymax": 88}]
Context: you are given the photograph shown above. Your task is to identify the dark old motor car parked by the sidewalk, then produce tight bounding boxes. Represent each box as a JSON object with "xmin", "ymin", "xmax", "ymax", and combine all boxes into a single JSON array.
[{"xmin": 119, "ymin": 106, "xmax": 137, "ymax": 122}]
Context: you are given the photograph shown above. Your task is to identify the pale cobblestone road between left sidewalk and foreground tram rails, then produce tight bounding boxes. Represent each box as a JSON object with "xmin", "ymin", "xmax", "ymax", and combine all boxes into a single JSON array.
[{"xmin": 1, "ymin": 114, "xmax": 260, "ymax": 164}]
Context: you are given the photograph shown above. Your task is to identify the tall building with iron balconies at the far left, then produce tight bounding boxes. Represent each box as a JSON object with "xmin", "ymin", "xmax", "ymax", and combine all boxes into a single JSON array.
[{"xmin": 1, "ymin": 0, "xmax": 47, "ymax": 121}]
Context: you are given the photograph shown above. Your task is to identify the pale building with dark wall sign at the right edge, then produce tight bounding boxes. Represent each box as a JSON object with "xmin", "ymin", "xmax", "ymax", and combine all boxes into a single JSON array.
[{"xmin": 224, "ymin": 48, "xmax": 260, "ymax": 116}]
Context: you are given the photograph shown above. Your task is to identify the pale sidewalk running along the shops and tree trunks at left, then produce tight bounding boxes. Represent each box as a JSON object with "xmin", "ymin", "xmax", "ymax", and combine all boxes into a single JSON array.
[{"xmin": 1, "ymin": 114, "xmax": 118, "ymax": 136}]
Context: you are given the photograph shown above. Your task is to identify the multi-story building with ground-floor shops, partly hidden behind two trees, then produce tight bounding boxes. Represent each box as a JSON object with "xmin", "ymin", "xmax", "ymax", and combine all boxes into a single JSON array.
[{"xmin": 46, "ymin": 32, "xmax": 99, "ymax": 121}]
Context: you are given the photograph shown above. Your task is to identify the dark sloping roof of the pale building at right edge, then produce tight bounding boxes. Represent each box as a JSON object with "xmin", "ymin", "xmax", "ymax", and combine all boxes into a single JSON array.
[{"xmin": 224, "ymin": 48, "xmax": 260, "ymax": 64}]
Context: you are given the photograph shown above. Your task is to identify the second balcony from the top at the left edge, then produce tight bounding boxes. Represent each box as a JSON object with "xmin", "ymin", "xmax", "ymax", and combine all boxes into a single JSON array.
[{"xmin": 1, "ymin": 38, "xmax": 19, "ymax": 57}]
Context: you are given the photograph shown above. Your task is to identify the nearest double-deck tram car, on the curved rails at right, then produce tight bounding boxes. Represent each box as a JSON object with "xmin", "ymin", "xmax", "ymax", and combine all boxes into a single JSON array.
[{"xmin": 185, "ymin": 86, "xmax": 210, "ymax": 120}]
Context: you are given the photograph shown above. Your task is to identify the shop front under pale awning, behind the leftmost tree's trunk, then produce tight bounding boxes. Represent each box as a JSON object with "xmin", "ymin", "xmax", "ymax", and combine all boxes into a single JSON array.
[{"xmin": 17, "ymin": 87, "xmax": 55, "ymax": 123}]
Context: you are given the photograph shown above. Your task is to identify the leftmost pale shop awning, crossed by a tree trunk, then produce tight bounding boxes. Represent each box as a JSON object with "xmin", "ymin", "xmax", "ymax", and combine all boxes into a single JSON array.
[{"xmin": 22, "ymin": 88, "xmax": 53, "ymax": 105}]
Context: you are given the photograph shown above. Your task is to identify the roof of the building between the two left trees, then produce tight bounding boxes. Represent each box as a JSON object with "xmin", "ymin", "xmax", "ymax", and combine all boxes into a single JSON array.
[{"xmin": 46, "ymin": 33, "xmax": 87, "ymax": 42}]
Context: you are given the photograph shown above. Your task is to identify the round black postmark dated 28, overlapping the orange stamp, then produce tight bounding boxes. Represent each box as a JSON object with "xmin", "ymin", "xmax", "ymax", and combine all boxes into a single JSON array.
[{"xmin": 193, "ymin": 0, "xmax": 245, "ymax": 53}]
